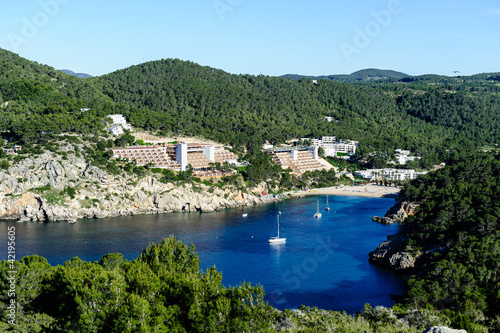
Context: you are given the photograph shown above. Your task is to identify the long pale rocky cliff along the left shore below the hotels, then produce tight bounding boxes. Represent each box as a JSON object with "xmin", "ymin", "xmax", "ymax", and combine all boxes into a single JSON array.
[{"xmin": 0, "ymin": 147, "xmax": 288, "ymax": 222}]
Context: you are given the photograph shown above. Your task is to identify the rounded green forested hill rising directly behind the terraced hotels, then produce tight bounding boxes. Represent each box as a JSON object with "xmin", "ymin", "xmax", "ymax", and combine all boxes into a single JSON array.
[{"xmin": 91, "ymin": 59, "xmax": 457, "ymax": 161}]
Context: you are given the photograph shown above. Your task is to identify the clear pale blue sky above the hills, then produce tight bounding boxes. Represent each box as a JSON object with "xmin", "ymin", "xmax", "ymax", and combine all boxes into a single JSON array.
[{"xmin": 0, "ymin": 0, "xmax": 500, "ymax": 76}]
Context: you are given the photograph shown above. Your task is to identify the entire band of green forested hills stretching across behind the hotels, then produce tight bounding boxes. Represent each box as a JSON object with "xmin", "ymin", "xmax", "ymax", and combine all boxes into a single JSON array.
[{"xmin": 0, "ymin": 49, "xmax": 500, "ymax": 165}]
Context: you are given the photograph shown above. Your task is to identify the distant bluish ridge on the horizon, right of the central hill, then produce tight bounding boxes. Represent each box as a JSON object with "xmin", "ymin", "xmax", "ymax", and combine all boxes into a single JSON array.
[{"xmin": 281, "ymin": 68, "xmax": 410, "ymax": 83}]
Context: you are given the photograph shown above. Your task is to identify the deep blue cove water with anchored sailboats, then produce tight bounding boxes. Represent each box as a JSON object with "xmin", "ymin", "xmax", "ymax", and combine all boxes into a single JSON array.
[{"xmin": 0, "ymin": 196, "xmax": 404, "ymax": 313}]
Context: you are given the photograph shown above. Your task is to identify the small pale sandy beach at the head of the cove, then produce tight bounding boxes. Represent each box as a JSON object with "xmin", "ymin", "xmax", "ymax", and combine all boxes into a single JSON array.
[{"xmin": 299, "ymin": 185, "xmax": 400, "ymax": 198}]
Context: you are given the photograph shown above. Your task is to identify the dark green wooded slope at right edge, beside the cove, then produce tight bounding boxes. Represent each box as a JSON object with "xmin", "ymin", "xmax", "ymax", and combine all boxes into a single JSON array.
[{"xmin": 400, "ymin": 154, "xmax": 500, "ymax": 332}]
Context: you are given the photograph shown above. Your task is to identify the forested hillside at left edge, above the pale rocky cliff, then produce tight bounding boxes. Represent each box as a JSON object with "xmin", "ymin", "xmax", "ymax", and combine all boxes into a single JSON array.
[{"xmin": 0, "ymin": 49, "xmax": 146, "ymax": 146}]
